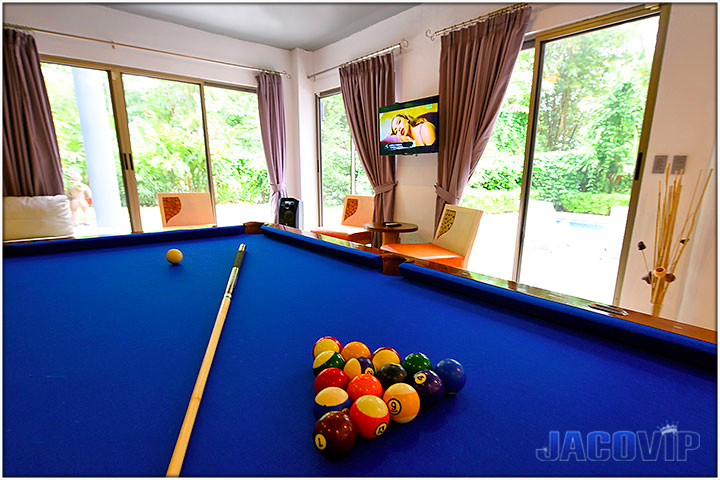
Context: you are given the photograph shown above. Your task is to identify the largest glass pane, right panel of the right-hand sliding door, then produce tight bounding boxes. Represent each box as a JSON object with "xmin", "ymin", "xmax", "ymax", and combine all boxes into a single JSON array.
[{"xmin": 520, "ymin": 17, "xmax": 658, "ymax": 303}]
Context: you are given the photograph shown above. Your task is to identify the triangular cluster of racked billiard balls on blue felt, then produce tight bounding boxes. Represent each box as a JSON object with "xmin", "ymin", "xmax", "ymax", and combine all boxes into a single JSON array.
[{"xmin": 313, "ymin": 337, "xmax": 465, "ymax": 457}]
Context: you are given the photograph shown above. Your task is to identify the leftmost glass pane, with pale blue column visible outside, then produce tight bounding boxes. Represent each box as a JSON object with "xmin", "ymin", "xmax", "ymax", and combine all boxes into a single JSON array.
[{"xmin": 41, "ymin": 63, "xmax": 131, "ymax": 237}]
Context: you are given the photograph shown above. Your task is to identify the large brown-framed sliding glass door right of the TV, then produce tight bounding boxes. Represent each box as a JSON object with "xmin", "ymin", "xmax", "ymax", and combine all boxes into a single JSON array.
[{"xmin": 462, "ymin": 6, "xmax": 667, "ymax": 303}]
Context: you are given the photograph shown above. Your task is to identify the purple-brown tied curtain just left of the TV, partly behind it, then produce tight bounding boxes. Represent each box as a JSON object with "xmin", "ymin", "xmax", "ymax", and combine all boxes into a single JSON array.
[{"xmin": 340, "ymin": 53, "xmax": 397, "ymax": 244}]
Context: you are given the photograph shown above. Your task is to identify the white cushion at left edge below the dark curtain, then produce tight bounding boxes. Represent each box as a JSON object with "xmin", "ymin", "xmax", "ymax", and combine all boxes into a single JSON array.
[{"xmin": 3, "ymin": 195, "xmax": 73, "ymax": 240}]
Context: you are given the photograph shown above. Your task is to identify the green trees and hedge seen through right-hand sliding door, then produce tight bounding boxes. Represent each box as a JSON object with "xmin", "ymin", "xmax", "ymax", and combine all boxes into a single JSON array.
[{"xmin": 462, "ymin": 19, "xmax": 657, "ymax": 215}]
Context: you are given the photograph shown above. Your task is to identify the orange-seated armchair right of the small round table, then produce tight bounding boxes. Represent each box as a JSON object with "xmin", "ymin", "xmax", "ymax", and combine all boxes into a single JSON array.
[{"xmin": 380, "ymin": 205, "xmax": 483, "ymax": 268}]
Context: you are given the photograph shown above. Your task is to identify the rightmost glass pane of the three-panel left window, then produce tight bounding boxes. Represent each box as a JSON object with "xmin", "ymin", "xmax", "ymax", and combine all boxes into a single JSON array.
[{"xmin": 205, "ymin": 87, "xmax": 272, "ymax": 225}]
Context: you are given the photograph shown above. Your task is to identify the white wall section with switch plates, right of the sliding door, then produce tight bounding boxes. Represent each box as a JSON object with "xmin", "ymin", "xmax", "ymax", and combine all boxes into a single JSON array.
[{"xmin": 620, "ymin": 4, "xmax": 717, "ymax": 329}]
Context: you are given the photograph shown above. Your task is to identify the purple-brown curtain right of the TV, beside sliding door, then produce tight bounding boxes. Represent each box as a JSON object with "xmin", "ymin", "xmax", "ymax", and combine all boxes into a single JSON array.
[{"xmin": 435, "ymin": 6, "xmax": 531, "ymax": 226}]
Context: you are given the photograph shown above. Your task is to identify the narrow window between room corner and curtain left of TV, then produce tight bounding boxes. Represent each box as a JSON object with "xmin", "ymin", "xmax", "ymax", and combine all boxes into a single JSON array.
[{"xmin": 318, "ymin": 93, "xmax": 373, "ymax": 225}]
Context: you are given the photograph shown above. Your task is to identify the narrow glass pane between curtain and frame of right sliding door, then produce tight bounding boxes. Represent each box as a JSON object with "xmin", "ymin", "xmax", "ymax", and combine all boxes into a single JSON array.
[{"xmin": 460, "ymin": 48, "xmax": 535, "ymax": 280}]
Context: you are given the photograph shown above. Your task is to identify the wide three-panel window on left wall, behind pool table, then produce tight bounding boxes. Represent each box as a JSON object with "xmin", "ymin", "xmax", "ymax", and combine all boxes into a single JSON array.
[{"xmin": 41, "ymin": 62, "xmax": 271, "ymax": 236}]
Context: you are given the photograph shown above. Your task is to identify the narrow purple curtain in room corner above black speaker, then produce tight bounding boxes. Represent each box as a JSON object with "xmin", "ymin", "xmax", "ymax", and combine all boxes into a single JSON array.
[{"xmin": 257, "ymin": 73, "xmax": 287, "ymax": 223}]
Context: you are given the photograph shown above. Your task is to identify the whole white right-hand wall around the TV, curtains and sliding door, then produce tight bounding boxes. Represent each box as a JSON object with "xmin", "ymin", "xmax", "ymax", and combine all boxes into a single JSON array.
[{"xmin": 312, "ymin": 4, "xmax": 717, "ymax": 329}]
